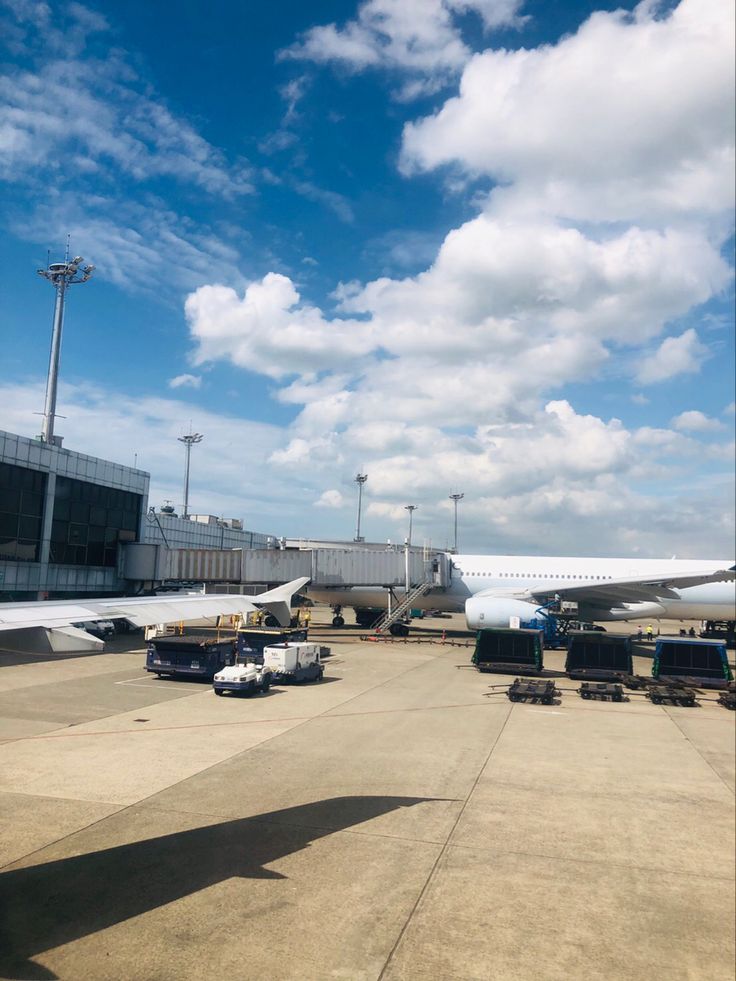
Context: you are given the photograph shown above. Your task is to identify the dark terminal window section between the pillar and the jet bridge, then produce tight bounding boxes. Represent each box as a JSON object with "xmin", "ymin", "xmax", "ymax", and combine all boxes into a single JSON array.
[{"xmin": 50, "ymin": 477, "xmax": 142, "ymax": 567}]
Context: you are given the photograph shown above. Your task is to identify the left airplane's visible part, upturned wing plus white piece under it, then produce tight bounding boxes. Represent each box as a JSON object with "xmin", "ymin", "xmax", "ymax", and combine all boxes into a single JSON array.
[{"xmin": 0, "ymin": 577, "xmax": 309, "ymax": 653}]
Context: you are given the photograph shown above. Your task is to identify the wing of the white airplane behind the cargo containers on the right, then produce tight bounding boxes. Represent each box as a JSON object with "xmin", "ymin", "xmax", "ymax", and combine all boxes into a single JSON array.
[{"xmin": 526, "ymin": 566, "xmax": 736, "ymax": 609}]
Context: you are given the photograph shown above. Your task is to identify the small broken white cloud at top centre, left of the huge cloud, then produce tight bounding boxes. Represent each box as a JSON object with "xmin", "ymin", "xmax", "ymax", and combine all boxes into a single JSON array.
[{"xmin": 281, "ymin": 0, "xmax": 523, "ymax": 98}]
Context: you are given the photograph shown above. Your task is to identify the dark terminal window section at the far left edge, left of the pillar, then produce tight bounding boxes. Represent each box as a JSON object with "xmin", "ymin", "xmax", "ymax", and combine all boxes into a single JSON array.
[{"xmin": 0, "ymin": 463, "xmax": 46, "ymax": 562}]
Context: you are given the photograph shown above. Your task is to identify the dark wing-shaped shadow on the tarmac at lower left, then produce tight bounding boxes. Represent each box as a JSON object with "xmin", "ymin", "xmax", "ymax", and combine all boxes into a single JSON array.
[{"xmin": 0, "ymin": 797, "xmax": 431, "ymax": 981}]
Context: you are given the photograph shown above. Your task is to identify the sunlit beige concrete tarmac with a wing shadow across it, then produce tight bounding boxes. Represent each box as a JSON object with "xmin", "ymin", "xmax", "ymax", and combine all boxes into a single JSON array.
[{"xmin": 0, "ymin": 608, "xmax": 735, "ymax": 981}]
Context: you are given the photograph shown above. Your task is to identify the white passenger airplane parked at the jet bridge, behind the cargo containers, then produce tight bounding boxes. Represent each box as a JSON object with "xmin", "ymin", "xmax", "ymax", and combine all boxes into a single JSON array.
[{"xmin": 309, "ymin": 555, "xmax": 736, "ymax": 630}]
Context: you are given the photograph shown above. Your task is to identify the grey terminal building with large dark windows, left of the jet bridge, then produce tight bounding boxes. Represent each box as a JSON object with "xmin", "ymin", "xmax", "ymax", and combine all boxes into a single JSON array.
[{"xmin": 0, "ymin": 430, "xmax": 275, "ymax": 601}]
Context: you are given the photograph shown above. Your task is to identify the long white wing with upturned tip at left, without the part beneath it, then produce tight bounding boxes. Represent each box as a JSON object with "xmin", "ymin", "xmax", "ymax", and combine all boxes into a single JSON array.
[{"xmin": 0, "ymin": 577, "xmax": 309, "ymax": 631}]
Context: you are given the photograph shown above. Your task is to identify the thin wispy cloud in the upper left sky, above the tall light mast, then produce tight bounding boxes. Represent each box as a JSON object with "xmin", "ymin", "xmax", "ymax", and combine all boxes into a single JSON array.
[{"xmin": 0, "ymin": 19, "xmax": 253, "ymax": 198}]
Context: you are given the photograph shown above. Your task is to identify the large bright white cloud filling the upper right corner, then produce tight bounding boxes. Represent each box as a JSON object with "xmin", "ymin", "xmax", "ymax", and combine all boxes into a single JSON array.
[{"xmin": 402, "ymin": 0, "xmax": 734, "ymax": 220}]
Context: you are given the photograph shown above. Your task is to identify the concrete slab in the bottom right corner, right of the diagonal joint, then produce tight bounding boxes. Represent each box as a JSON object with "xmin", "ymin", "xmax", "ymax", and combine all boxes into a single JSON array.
[{"xmin": 382, "ymin": 844, "xmax": 734, "ymax": 981}]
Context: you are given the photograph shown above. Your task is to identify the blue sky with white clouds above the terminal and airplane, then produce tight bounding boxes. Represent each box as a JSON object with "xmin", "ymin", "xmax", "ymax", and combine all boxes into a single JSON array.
[{"xmin": 0, "ymin": 0, "xmax": 734, "ymax": 558}]
